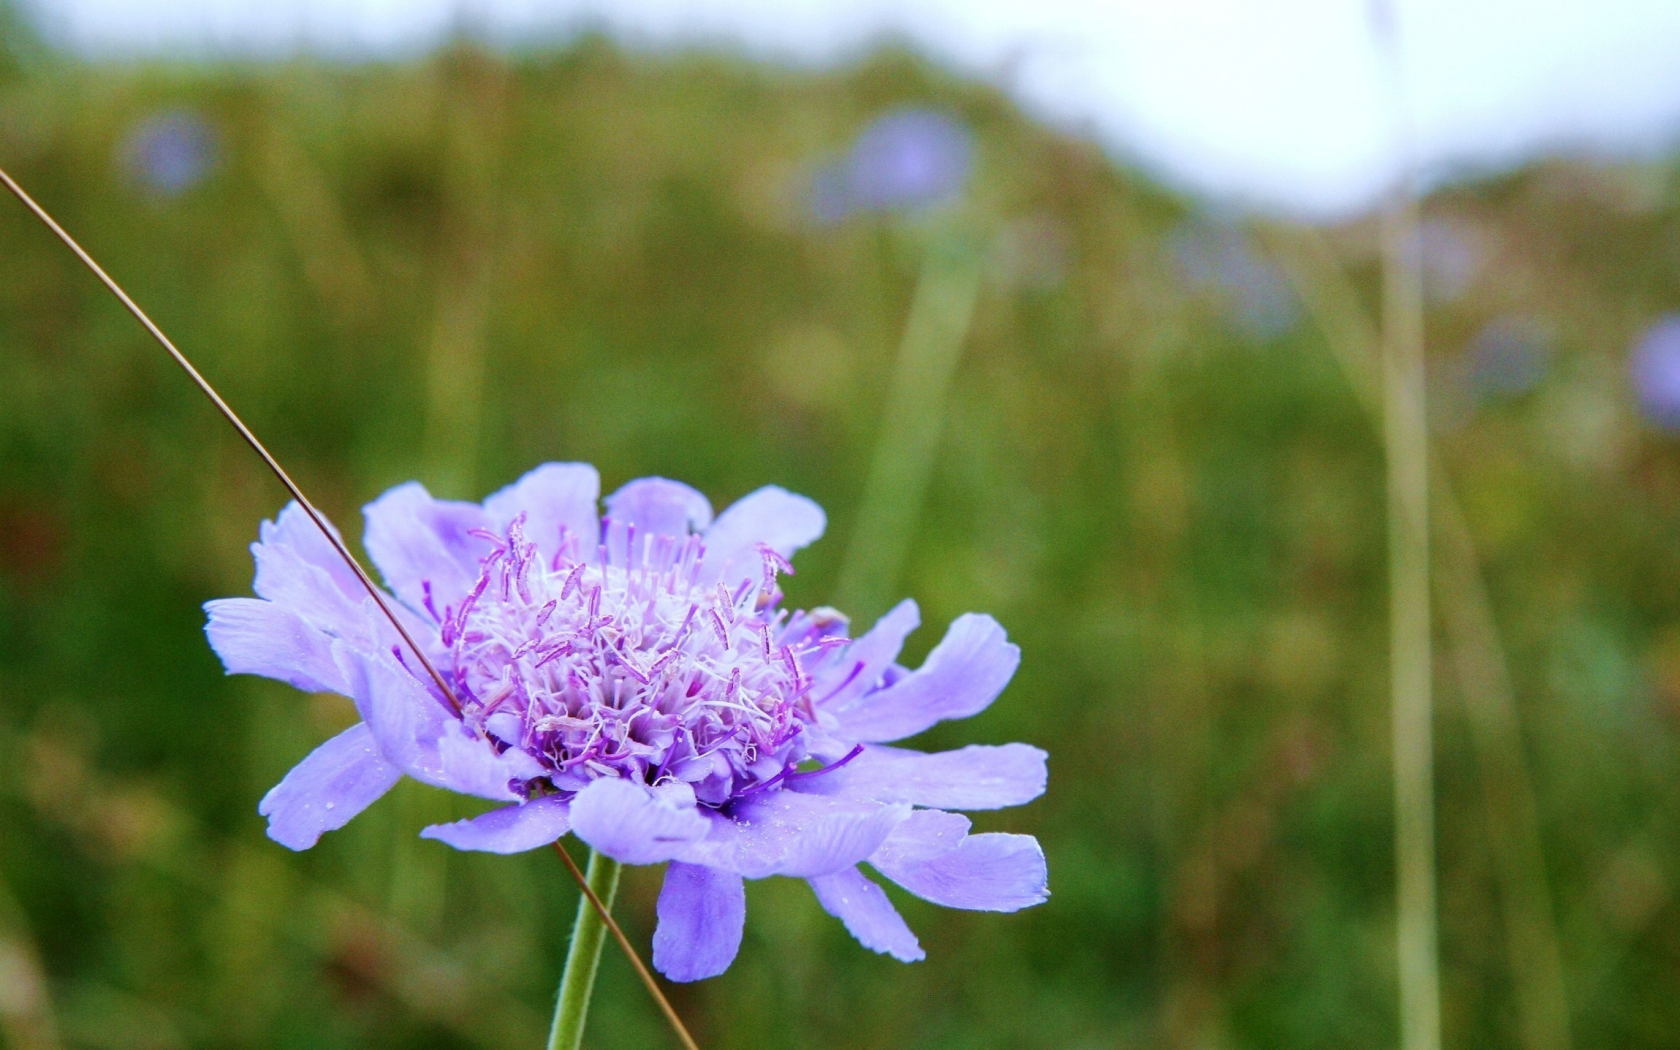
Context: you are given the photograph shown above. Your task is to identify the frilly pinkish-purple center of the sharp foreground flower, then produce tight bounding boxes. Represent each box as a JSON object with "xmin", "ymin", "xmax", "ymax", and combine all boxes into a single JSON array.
[{"xmin": 427, "ymin": 516, "xmax": 847, "ymax": 806}]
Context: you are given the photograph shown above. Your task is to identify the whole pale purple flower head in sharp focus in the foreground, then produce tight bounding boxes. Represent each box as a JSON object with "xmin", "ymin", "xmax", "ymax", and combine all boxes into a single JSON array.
[{"xmin": 205, "ymin": 464, "xmax": 1048, "ymax": 981}]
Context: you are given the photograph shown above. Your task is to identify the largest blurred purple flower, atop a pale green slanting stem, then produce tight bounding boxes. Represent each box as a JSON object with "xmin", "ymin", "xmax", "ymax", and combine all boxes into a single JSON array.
[{"xmin": 811, "ymin": 109, "xmax": 974, "ymax": 222}]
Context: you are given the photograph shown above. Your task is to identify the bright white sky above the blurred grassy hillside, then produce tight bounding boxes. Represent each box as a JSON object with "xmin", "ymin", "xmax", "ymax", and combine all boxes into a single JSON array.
[{"xmin": 22, "ymin": 0, "xmax": 1680, "ymax": 213}]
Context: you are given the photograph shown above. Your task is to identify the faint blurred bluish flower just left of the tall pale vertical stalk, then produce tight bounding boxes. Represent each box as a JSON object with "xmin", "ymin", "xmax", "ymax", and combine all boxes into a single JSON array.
[{"xmin": 1168, "ymin": 222, "xmax": 1297, "ymax": 341}]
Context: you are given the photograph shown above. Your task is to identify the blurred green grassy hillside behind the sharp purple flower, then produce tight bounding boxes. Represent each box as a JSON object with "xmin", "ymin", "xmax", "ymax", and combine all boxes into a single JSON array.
[{"xmin": 0, "ymin": 18, "xmax": 1680, "ymax": 1050}]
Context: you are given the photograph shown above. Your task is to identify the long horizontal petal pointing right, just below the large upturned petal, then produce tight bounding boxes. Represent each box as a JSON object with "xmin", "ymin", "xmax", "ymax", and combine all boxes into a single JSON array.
[{"xmin": 800, "ymin": 744, "xmax": 1050, "ymax": 810}]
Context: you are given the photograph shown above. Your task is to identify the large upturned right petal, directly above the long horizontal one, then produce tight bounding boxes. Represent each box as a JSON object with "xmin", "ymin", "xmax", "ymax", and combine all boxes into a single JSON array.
[{"xmin": 830, "ymin": 613, "xmax": 1021, "ymax": 744}]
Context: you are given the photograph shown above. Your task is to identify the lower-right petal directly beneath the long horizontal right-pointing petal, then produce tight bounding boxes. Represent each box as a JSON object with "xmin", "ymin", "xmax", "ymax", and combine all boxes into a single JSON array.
[{"xmin": 869, "ymin": 826, "xmax": 1050, "ymax": 912}]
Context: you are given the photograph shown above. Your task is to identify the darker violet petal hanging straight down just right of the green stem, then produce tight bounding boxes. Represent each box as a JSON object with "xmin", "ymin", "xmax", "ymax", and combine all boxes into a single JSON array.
[{"xmin": 654, "ymin": 860, "xmax": 746, "ymax": 981}]
